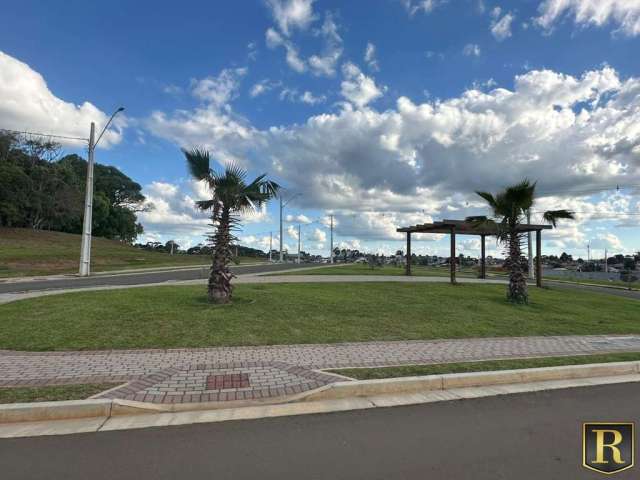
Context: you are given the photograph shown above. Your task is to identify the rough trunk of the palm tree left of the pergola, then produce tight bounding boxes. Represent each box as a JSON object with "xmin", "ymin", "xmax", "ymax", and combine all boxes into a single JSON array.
[{"xmin": 208, "ymin": 207, "xmax": 233, "ymax": 304}]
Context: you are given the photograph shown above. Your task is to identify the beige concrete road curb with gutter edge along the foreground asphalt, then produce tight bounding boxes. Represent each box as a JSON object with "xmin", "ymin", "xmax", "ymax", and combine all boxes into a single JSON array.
[{"xmin": 0, "ymin": 361, "xmax": 640, "ymax": 432}]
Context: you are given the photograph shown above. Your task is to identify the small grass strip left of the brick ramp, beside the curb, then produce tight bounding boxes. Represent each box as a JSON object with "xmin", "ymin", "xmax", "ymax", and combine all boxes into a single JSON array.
[{"xmin": 0, "ymin": 383, "xmax": 119, "ymax": 404}]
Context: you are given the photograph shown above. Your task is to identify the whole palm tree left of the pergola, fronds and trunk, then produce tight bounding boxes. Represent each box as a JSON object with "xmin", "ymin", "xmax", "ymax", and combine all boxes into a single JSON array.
[{"xmin": 182, "ymin": 148, "xmax": 280, "ymax": 303}]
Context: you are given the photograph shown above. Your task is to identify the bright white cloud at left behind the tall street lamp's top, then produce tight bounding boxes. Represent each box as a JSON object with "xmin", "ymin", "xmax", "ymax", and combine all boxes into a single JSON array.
[{"xmin": 0, "ymin": 51, "xmax": 127, "ymax": 148}]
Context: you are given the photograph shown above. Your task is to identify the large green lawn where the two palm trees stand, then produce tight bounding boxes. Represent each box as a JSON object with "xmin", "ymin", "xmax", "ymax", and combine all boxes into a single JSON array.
[{"xmin": 0, "ymin": 283, "xmax": 640, "ymax": 351}]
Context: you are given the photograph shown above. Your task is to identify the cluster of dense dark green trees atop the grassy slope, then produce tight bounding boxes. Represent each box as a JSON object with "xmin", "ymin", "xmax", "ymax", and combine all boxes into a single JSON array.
[{"xmin": 0, "ymin": 131, "xmax": 150, "ymax": 243}]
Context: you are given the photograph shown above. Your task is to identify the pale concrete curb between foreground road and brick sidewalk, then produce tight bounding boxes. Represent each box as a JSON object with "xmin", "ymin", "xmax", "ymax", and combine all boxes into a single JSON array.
[{"xmin": 0, "ymin": 361, "xmax": 640, "ymax": 430}]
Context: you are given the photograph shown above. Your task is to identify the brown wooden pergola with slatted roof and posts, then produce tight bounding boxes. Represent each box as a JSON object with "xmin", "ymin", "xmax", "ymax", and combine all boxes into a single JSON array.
[{"xmin": 396, "ymin": 220, "xmax": 552, "ymax": 287}]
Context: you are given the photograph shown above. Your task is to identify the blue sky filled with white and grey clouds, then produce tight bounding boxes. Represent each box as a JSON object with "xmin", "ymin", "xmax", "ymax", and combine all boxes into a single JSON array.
[{"xmin": 0, "ymin": 0, "xmax": 640, "ymax": 258}]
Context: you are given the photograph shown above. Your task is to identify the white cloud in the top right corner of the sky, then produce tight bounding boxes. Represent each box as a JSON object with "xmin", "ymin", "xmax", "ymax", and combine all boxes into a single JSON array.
[{"xmin": 535, "ymin": 0, "xmax": 640, "ymax": 36}]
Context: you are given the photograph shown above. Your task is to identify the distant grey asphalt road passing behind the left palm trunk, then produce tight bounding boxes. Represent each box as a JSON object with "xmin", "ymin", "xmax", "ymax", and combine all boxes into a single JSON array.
[{"xmin": 0, "ymin": 263, "xmax": 313, "ymax": 294}]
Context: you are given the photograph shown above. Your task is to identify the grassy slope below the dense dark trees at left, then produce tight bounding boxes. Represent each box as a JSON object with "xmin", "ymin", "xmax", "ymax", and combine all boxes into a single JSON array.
[{"xmin": 0, "ymin": 228, "xmax": 256, "ymax": 278}]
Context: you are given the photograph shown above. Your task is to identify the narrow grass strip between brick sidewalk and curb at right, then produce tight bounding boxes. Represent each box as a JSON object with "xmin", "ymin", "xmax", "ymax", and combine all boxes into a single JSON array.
[{"xmin": 328, "ymin": 352, "xmax": 640, "ymax": 380}]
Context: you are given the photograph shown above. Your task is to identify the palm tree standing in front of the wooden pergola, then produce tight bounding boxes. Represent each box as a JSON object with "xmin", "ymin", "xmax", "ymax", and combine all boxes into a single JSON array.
[{"xmin": 467, "ymin": 179, "xmax": 574, "ymax": 303}]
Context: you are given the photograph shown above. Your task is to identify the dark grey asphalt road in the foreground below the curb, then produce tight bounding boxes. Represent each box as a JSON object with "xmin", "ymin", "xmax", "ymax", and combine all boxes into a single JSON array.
[{"xmin": 0, "ymin": 383, "xmax": 640, "ymax": 480}]
